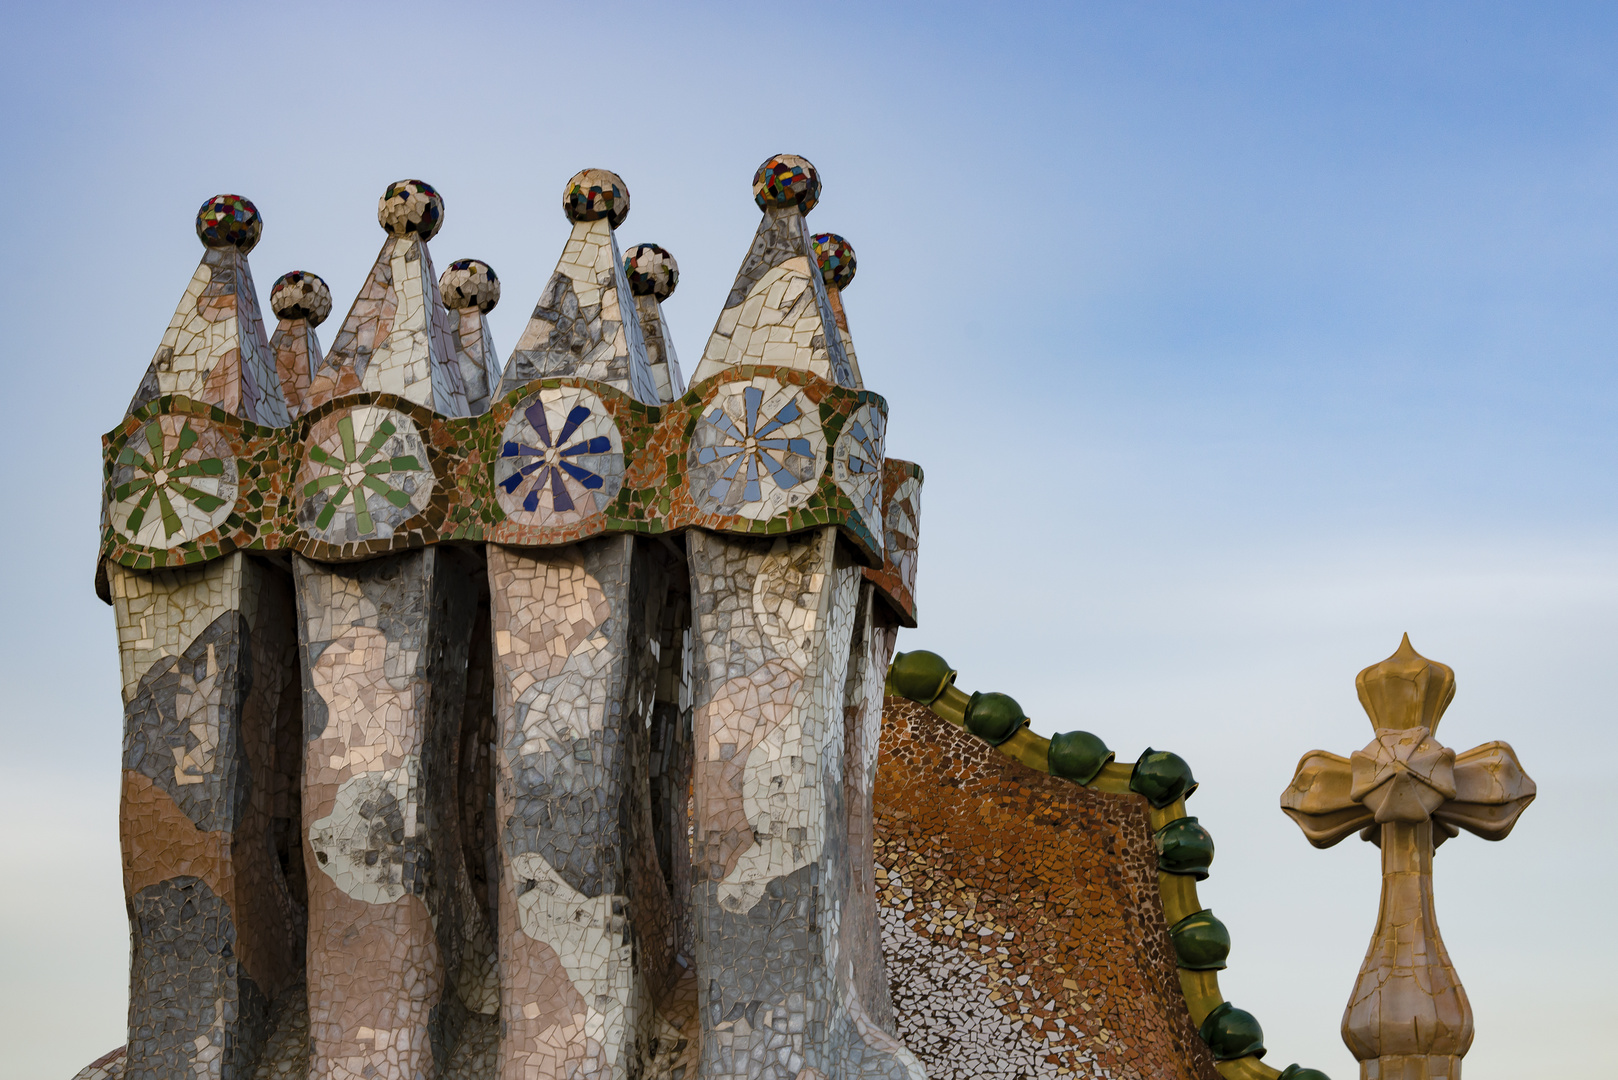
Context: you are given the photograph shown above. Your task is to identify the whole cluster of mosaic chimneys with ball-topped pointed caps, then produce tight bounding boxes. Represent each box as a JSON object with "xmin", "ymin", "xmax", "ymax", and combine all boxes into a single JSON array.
[{"xmin": 97, "ymin": 157, "xmax": 922, "ymax": 1080}]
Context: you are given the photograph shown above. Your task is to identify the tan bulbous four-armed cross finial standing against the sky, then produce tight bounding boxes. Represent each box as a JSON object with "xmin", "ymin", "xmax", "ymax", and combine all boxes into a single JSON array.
[{"xmin": 1281, "ymin": 635, "xmax": 1535, "ymax": 1080}]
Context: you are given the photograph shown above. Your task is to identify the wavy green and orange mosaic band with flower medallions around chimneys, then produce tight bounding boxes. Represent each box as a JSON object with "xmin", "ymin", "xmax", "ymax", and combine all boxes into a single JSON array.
[{"xmin": 102, "ymin": 366, "xmax": 899, "ymax": 569}]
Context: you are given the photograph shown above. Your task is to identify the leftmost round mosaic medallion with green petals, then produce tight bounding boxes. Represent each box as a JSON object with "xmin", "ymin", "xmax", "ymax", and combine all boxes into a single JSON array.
[{"xmin": 108, "ymin": 415, "xmax": 236, "ymax": 547}]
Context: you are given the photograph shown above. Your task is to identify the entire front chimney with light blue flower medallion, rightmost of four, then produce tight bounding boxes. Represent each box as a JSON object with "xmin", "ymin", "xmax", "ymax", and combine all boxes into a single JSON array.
[{"xmin": 686, "ymin": 155, "xmax": 924, "ymax": 1080}]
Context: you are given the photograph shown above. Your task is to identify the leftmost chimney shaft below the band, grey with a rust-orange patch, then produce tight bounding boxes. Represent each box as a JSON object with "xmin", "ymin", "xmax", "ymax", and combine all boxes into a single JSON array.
[{"xmin": 108, "ymin": 552, "xmax": 304, "ymax": 1080}]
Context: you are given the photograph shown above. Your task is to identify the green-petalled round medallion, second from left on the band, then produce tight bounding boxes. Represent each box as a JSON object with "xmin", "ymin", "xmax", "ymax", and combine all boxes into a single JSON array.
[{"xmin": 294, "ymin": 405, "xmax": 434, "ymax": 544}]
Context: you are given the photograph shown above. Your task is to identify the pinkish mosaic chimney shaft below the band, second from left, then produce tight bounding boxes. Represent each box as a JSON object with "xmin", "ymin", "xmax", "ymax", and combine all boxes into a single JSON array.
[{"xmin": 296, "ymin": 546, "xmax": 482, "ymax": 1080}]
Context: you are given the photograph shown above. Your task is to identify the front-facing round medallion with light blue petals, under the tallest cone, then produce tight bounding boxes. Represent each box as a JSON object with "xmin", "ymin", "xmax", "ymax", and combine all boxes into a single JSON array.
[{"xmin": 686, "ymin": 376, "xmax": 825, "ymax": 521}]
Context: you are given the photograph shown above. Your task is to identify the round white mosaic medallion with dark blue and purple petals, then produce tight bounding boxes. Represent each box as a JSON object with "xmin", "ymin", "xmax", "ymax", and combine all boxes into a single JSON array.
[{"xmin": 495, "ymin": 387, "xmax": 623, "ymax": 526}]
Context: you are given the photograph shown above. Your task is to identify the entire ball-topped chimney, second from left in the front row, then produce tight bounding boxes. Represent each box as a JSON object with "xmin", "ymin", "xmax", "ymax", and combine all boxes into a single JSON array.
[{"xmin": 293, "ymin": 180, "xmax": 493, "ymax": 1080}]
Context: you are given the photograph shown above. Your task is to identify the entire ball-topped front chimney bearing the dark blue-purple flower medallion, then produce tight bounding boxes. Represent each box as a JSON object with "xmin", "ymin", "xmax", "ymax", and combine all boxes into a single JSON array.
[{"xmin": 475, "ymin": 170, "xmax": 694, "ymax": 1080}]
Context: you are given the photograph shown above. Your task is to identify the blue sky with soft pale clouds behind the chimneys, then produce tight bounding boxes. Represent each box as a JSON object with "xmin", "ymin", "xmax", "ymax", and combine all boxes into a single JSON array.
[{"xmin": 0, "ymin": 0, "xmax": 1618, "ymax": 1080}]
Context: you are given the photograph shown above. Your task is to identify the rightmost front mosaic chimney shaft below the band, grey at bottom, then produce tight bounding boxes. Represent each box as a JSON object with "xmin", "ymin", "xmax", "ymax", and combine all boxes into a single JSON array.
[{"xmin": 688, "ymin": 529, "xmax": 921, "ymax": 1080}]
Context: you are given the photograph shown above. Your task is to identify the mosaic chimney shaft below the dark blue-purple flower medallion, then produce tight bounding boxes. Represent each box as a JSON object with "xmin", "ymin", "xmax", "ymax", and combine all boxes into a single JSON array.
[{"xmin": 489, "ymin": 536, "xmax": 684, "ymax": 1080}]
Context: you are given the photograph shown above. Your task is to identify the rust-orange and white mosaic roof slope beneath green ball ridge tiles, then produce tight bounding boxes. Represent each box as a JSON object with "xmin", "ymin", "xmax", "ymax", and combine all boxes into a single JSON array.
[{"xmin": 874, "ymin": 698, "xmax": 1218, "ymax": 1080}]
